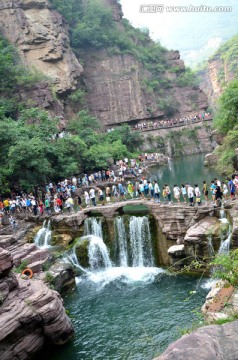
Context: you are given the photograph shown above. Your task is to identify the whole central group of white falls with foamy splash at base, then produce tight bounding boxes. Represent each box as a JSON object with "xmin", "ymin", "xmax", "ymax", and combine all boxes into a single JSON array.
[{"xmin": 66, "ymin": 216, "xmax": 161, "ymax": 288}]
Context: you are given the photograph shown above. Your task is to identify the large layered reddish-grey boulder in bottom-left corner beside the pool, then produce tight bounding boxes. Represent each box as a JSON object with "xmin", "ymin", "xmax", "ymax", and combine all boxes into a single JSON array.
[{"xmin": 0, "ymin": 248, "xmax": 73, "ymax": 360}]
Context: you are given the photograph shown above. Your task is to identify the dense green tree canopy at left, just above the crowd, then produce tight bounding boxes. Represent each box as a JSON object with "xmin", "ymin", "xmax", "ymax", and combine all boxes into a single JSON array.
[{"xmin": 0, "ymin": 108, "xmax": 140, "ymax": 192}]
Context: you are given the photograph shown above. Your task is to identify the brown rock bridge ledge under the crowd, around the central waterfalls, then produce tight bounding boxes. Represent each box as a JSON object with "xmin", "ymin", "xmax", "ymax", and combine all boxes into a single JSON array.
[{"xmin": 52, "ymin": 200, "xmax": 219, "ymax": 266}]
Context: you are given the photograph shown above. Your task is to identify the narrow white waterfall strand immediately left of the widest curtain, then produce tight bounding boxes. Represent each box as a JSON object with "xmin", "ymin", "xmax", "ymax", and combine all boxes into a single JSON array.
[{"xmin": 115, "ymin": 217, "xmax": 128, "ymax": 267}]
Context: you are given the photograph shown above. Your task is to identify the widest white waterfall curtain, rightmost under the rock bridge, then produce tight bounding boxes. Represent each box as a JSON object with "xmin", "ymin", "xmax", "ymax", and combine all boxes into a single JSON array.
[{"xmin": 130, "ymin": 216, "xmax": 154, "ymax": 267}]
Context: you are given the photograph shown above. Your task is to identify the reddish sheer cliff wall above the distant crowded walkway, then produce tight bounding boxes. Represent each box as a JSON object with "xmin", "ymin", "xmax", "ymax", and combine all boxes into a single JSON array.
[{"xmin": 83, "ymin": 50, "xmax": 207, "ymax": 125}]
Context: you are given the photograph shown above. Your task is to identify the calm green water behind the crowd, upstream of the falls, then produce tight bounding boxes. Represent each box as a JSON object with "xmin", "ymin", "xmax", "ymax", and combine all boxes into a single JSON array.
[{"xmin": 149, "ymin": 154, "xmax": 220, "ymax": 189}]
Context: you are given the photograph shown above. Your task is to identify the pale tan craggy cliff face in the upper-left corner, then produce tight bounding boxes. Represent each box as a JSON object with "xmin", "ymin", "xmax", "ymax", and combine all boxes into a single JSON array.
[{"xmin": 0, "ymin": 0, "xmax": 83, "ymax": 93}]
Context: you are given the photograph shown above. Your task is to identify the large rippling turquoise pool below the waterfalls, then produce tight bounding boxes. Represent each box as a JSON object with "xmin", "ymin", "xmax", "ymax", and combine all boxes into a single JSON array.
[{"xmin": 45, "ymin": 274, "xmax": 207, "ymax": 360}]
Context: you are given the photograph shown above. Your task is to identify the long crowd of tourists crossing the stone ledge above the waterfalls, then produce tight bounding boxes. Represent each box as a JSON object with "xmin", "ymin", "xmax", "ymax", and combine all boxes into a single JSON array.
[{"xmin": 0, "ymin": 169, "xmax": 238, "ymax": 228}]
